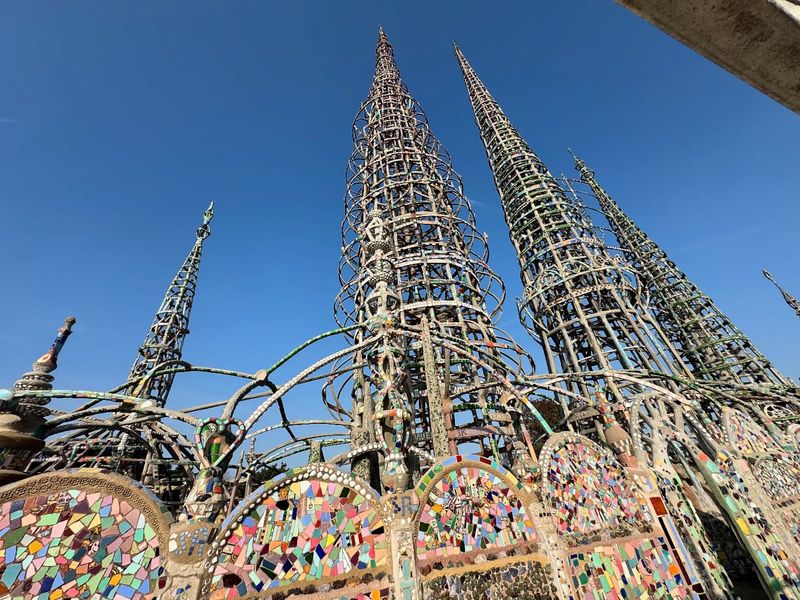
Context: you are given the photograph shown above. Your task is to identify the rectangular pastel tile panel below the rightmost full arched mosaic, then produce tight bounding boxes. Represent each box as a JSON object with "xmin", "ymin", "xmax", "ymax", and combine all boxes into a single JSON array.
[{"xmin": 569, "ymin": 537, "xmax": 696, "ymax": 600}]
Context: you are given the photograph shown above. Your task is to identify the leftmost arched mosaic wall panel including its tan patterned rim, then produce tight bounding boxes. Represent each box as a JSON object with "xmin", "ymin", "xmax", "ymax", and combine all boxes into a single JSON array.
[{"xmin": 0, "ymin": 469, "xmax": 172, "ymax": 600}]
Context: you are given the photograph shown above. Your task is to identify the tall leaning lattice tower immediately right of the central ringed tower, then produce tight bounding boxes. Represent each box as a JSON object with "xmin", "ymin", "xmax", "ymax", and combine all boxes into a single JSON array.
[{"xmin": 455, "ymin": 42, "xmax": 686, "ymax": 408}]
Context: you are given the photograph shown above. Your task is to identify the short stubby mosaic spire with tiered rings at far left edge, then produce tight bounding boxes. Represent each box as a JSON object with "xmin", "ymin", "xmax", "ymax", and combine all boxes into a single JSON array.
[{"xmin": 0, "ymin": 317, "xmax": 75, "ymax": 485}]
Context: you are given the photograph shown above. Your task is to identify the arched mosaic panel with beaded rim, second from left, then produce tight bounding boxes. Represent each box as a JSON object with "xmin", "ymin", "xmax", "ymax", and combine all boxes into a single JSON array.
[{"xmin": 207, "ymin": 466, "xmax": 387, "ymax": 599}]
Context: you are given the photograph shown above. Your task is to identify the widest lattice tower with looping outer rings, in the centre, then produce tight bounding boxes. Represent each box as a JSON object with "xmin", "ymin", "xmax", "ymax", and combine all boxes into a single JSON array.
[{"xmin": 335, "ymin": 30, "xmax": 532, "ymax": 469}]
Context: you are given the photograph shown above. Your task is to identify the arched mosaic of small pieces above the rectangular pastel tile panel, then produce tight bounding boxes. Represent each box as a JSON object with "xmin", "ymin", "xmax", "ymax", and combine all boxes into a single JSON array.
[{"xmin": 541, "ymin": 434, "xmax": 649, "ymax": 543}]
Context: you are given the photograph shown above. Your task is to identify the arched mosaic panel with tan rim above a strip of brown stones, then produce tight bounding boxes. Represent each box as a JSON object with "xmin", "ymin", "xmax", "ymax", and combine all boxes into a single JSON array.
[{"xmin": 416, "ymin": 456, "xmax": 537, "ymax": 561}]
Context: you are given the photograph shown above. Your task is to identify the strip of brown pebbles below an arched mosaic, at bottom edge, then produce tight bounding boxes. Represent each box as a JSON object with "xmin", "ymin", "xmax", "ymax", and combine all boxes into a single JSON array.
[{"xmin": 422, "ymin": 562, "xmax": 558, "ymax": 600}]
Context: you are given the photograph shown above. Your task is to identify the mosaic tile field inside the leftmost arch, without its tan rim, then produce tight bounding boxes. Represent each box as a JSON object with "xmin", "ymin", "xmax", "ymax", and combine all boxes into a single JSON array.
[{"xmin": 0, "ymin": 490, "xmax": 159, "ymax": 600}]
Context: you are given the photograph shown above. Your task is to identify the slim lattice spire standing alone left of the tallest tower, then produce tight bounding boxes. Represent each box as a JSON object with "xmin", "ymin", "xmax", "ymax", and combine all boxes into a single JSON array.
[{"xmin": 128, "ymin": 200, "xmax": 214, "ymax": 406}]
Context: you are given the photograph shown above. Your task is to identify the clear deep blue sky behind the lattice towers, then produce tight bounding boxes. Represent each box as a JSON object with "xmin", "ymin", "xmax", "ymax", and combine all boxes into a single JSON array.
[{"xmin": 0, "ymin": 0, "xmax": 800, "ymax": 420}]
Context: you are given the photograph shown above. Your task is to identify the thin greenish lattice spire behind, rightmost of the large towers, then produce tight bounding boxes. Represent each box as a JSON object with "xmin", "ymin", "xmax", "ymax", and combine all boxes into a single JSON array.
[{"xmin": 573, "ymin": 154, "xmax": 787, "ymax": 385}]
